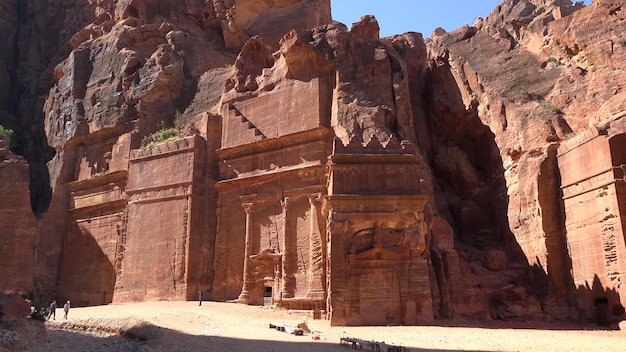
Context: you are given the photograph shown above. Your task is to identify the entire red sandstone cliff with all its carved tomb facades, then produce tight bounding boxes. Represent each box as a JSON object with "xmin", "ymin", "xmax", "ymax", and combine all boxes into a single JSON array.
[{"xmin": 0, "ymin": 0, "xmax": 626, "ymax": 325}]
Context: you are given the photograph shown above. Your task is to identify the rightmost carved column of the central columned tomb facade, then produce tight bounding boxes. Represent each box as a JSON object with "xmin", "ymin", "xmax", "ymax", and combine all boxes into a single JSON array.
[{"xmin": 306, "ymin": 193, "xmax": 325, "ymax": 300}]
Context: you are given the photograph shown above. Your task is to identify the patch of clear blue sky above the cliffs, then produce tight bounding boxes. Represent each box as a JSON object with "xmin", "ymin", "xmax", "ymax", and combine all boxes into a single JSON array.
[{"xmin": 331, "ymin": 0, "xmax": 591, "ymax": 38}]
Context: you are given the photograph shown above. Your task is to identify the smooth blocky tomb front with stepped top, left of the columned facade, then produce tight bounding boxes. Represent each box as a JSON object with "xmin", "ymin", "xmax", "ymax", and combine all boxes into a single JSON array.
[{"xmin": 119, "ymin": 137, "xmax": 209, "ymax": 302}]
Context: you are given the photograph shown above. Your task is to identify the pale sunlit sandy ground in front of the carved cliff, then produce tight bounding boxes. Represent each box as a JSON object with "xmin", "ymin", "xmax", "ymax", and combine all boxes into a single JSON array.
[{"xmin": 35, "ymin": 302, "xmax": 626, "ymax": 352}]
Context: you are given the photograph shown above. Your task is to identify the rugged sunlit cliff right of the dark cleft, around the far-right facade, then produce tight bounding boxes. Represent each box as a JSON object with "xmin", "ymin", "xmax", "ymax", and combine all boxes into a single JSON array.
[{"xmin": 429, "ymin": 1, "xmax": 624, "ymax": 320}]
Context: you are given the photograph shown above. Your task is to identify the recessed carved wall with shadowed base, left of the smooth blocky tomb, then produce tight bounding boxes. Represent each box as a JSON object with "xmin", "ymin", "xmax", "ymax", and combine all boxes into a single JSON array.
[{"xmin": 55, "ymin": 134, "xmax": 132, "ymax": 306}]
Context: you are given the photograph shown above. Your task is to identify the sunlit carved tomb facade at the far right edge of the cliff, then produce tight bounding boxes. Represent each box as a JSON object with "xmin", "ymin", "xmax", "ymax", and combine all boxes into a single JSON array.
[{"xmin": 559, "ymin": 129, "xmax": 626, "ymax": 323}]
